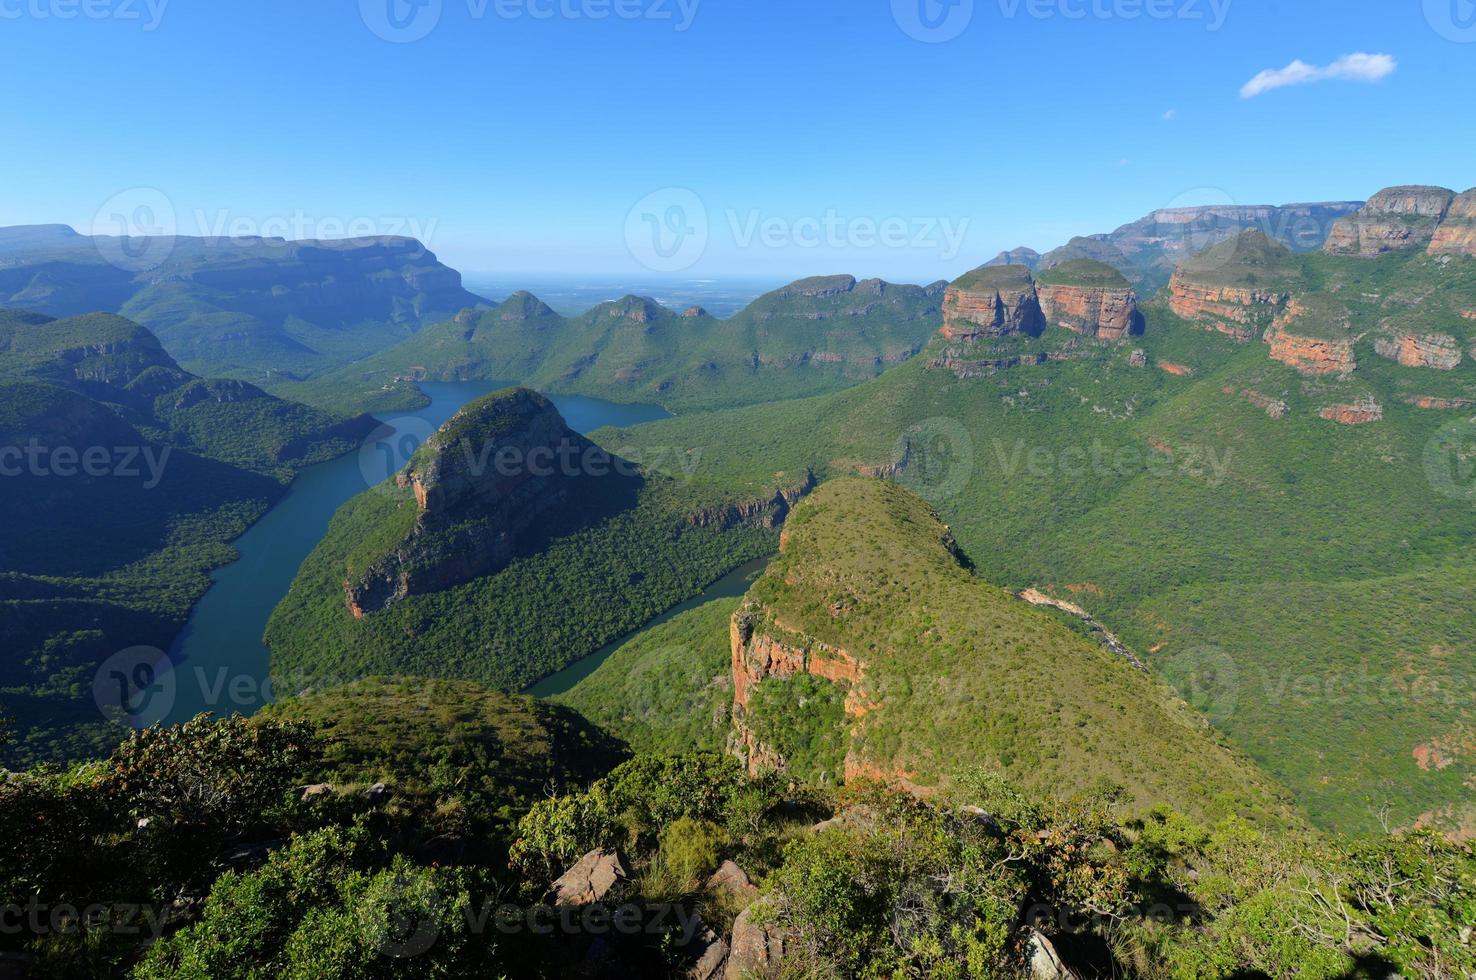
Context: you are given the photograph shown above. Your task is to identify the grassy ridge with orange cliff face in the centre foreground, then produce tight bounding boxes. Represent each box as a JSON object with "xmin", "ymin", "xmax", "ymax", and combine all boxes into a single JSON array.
[{"xmin": 731, "ymin": 478, "xmax": 1280, "ymax": 815}]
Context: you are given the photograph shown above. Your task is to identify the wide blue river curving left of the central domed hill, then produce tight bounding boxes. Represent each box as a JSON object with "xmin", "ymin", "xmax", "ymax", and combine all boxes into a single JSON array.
[{"xmin": 161, "ymin": 381, "xmax": 669, "ymax": 723}]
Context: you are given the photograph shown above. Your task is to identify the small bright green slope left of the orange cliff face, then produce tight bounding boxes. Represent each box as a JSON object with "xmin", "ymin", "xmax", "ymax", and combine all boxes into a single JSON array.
[{"xmin": 554, "ymin": 599, "xmax": 738, "ymax": 754}]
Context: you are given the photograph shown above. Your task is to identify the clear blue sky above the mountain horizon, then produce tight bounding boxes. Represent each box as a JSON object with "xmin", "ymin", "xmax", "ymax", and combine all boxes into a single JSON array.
[{"xmin": 0, "ymin": 0, "xmax": 1476, "ymax": 280}]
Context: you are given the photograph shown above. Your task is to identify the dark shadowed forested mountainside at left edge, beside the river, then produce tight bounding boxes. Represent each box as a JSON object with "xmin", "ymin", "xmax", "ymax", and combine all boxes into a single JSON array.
[{"xmin": 0, "ymin": 311, "xmax": 373, "ymax": 759}]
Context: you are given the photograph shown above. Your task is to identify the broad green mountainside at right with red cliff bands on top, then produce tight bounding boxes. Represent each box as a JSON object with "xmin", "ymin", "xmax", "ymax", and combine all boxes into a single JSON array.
[{"xmin": 584, "ymin": 208, "xmax": 1476, "ymax": 829}]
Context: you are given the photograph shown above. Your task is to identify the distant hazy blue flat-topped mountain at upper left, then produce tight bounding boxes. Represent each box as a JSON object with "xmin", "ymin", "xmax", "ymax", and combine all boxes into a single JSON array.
[{"xmin": 0, "ymin": 226, "xmax": 483, "ymax": 384}]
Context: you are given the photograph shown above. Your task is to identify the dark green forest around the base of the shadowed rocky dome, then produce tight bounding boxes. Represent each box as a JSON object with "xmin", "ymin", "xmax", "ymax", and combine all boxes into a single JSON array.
[{"xmin": 266, "ymin": 478, "xmax": 776, "ymax": 691}]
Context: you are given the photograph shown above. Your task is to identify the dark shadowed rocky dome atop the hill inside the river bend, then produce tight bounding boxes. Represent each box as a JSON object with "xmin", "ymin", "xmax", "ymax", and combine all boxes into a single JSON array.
[{"xmin": 344, "ymin": 388, "xmax": 636, "ymax": 618}]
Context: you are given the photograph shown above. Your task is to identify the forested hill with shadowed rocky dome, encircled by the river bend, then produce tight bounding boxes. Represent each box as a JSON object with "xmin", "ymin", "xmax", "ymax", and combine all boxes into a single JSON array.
[{"xmin": 266, "ymin": 388, "xmax": 812, "ymax": 691}]
